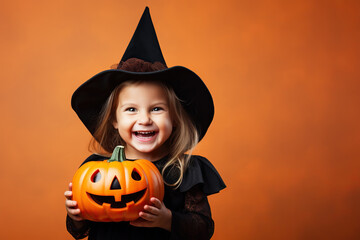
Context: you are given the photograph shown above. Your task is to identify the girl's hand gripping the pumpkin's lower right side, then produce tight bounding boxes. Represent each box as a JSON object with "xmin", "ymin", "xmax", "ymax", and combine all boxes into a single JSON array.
[{"xmin": 130, "ymin": 197, "xmax": 172, "ymax": 231}]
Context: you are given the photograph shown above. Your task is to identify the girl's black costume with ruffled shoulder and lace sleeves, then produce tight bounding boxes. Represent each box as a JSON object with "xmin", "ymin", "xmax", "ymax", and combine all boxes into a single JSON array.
[{"xmin": 66, "ymin": 154, "xmax": 225, "ymax": 240}]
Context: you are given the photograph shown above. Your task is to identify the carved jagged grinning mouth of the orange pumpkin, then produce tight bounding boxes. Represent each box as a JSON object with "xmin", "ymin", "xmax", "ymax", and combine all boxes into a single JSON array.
[{"xmin": 87, "ymin": 188, "xmax": 146, "ymax": 208}]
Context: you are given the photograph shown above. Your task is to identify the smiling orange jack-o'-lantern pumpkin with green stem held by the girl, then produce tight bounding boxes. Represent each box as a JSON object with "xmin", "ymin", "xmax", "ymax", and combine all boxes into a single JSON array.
[{"xmin": 72, "ymin": 146, "xmax": 164, "ymax": 222}]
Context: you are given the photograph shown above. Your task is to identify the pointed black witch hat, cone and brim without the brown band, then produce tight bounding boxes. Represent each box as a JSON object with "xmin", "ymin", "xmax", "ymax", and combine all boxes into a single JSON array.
[{"xmin": 71, "ymin": 7, "xmax": 214, "ymax": 140}]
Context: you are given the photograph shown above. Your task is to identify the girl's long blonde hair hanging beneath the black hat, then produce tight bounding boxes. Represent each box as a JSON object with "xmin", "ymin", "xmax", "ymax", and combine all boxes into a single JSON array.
[{"xmin": 89, "ymin": 80, "xmax": 199, "ymax": 188}]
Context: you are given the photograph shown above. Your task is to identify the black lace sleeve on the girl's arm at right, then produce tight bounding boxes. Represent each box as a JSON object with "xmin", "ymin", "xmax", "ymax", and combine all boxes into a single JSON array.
[{"xmin": 171, "ymin": 185, "xmax": 214, "ymax": 240}]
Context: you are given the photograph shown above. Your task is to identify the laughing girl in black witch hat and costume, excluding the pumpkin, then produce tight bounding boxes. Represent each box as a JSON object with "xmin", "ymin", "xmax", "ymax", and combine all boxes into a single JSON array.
[{"xmin": 65, "ymin": 8, "xmax": 225, "ymax": 240}]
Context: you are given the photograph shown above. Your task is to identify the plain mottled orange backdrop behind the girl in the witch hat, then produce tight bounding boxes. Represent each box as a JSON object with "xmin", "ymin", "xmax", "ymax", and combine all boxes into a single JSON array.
[{"xmin": 0, "ymin": 0, "xmax": 360, "ymax": 240}]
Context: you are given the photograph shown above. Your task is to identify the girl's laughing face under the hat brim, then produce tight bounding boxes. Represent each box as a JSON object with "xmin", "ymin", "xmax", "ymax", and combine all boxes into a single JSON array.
[{"xmin": 113, "ymin": 83, "xmax": 173, "ymax": 161}]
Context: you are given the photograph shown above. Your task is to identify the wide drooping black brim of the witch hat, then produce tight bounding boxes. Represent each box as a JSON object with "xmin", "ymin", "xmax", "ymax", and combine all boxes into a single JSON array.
[{"xmin": 71, "ymin": 66, "xmax": 214, "ymax": 140}]
